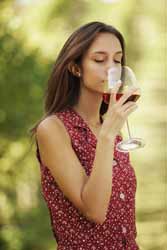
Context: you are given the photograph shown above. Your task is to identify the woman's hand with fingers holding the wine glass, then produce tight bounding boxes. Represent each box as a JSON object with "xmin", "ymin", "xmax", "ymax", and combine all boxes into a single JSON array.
[{"xmin": 100, "ymin": 83, "xmax": 138, "ymax": 139}]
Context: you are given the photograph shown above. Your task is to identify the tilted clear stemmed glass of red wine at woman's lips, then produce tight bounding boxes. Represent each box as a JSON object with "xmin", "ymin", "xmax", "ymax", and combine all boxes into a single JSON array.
[{"xmin": 103, "ymin": 66, "xmax": 145, "ymax": 152}]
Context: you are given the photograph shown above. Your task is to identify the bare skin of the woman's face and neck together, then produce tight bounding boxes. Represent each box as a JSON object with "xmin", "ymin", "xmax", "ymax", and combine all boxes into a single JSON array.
[{"xmin": 73, "ymin": 33, "xmax": 122, "ymax": 127}]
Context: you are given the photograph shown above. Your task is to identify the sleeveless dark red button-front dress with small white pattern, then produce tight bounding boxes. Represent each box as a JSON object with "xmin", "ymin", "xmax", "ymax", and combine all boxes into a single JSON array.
[{"xmin": 36, "ymin": 107, "xmax": 139, "ymax": 250}]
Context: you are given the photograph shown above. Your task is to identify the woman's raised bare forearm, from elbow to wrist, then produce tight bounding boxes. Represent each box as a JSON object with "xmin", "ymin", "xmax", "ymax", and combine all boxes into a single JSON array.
[{"xmin": 82, "ymin": 135, "xmax": 115, "ymax": 224}]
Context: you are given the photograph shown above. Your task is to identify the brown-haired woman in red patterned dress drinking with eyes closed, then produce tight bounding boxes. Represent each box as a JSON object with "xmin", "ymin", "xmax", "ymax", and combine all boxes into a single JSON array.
[{"xmin": 30, "ymin": 22, "xmax": 139, "ymax": 250}]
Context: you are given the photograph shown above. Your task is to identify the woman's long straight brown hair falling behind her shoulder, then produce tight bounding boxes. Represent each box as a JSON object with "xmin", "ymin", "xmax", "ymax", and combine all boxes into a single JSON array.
[{"xmin": 30, "ymin": 22, "xmax": 125, "ymax": 139}]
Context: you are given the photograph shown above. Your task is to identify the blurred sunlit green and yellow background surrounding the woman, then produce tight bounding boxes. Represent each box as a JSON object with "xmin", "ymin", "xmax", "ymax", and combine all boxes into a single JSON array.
[{"xmin": 0, "ymin": 0, "xmax": 167, "ymax": 250}]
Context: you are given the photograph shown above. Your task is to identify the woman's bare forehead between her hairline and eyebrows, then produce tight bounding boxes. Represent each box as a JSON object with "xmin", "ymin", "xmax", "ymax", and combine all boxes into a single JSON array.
[{"xmin": 87, "ymin": 33, "xmax": 122, "ymax": 54}]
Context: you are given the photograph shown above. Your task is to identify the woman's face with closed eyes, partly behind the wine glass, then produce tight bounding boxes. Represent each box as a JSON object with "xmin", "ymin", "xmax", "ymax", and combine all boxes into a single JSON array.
[{"xmin": 81, "ymin": 33, "xmax": 123, "ymax": 93}]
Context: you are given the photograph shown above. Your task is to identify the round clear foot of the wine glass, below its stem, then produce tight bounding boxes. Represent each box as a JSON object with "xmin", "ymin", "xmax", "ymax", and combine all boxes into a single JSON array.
[{"xmin": 116, "ymin": 138, "xmax": 145, "ymax": 152}]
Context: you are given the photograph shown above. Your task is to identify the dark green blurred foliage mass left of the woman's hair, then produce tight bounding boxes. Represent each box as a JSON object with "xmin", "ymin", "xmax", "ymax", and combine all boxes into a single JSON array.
[{"xmin": 0, "ymin": 24, "xmax": 49, "ymax": 139}]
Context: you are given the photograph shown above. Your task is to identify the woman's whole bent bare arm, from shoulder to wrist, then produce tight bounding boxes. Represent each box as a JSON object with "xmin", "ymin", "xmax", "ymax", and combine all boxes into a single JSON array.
[{"xmin": 36, "ymin": 116, "xmax": 114, "ymax": 223}]
